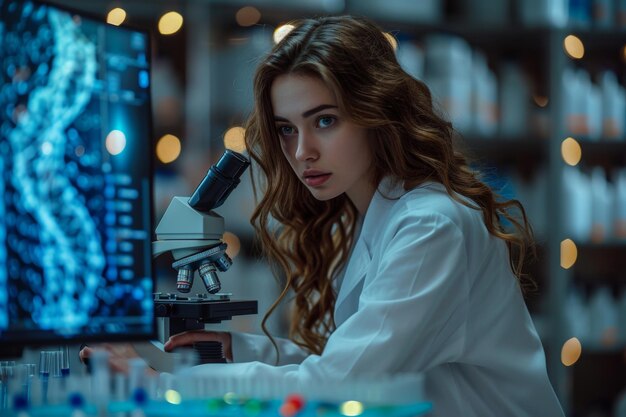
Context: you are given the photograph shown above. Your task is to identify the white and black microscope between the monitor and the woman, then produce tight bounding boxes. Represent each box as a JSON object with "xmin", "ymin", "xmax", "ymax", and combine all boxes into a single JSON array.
[{"xmin": 135, "ymin": 150, "xmax": 257, "ymax": 371}]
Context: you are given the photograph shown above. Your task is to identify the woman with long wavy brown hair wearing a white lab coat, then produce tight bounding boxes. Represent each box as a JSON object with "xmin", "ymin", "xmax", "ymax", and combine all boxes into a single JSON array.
[{"xmin": 81, "ymin": 17, "xmax": 563, "ymax": 416}]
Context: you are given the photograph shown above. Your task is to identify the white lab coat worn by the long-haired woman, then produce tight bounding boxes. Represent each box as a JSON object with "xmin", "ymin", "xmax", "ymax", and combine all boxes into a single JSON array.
[{"xmin": 188, "ymin": 181, "xmax": 563, "ymax": 417}]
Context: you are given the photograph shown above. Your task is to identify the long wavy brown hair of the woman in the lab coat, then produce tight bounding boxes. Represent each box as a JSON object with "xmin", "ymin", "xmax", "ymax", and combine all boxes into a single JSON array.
[{"xmin": 241, "ymin": 16, "xmax": 532, "ymax": 360}]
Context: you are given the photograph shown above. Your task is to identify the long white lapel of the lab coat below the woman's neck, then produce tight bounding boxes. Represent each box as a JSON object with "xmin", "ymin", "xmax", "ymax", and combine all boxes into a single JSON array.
[{"xmin": 334, "ymin": 178, "xmax": 405, "ymax": 325}]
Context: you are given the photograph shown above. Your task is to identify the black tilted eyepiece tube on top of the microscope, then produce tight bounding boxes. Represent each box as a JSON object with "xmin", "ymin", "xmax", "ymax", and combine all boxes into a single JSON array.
[{"xmin": 189, "ymin": 149, "xmax": 250, "ymax": 212}]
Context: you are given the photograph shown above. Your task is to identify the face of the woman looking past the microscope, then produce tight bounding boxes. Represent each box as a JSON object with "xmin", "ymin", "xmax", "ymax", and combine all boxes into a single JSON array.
[{"xmin": 271, "ymin": 74, "xmax": 375, "ymax": 214}]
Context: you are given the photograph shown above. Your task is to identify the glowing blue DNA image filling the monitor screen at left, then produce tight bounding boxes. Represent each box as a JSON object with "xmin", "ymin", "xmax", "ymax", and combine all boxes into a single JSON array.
[{"xmin": 0, "ymin": 0, "xmax": 154, "ymax": 343}]
